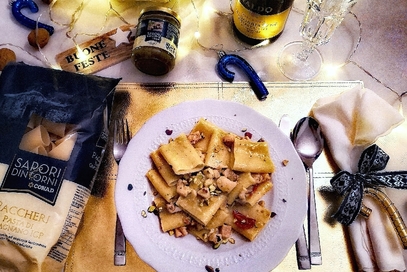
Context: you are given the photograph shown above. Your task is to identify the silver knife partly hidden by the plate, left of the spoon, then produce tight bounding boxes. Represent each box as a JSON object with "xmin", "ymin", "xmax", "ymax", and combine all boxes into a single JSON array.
[{"xmin": 278, "ymin": 114, "xmax": 311, "ymax": 270}]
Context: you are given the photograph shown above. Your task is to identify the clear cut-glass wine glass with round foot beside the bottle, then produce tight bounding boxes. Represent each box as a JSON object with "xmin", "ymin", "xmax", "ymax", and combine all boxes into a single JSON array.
[{"xmin": 278, "ymin": 0, "xmax": 357, "ymax": 80}]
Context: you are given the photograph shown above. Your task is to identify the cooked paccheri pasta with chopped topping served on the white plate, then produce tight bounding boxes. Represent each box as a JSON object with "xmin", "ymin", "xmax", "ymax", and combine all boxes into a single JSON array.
[{"xmin": 146, "ymin": 118, "xmax": 274, "ymax": 248}]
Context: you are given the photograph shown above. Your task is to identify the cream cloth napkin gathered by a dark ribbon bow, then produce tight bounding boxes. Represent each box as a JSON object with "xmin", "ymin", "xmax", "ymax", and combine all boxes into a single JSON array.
[{"xmin": 312, "ymin": 87, "xmax": 407, "ymax": 272}]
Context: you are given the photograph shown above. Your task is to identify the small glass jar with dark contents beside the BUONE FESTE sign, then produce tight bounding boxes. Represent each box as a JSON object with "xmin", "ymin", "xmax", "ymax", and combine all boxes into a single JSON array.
[{"xmin": 132, "ymin": 7, "xmax": 181, "ymax": 76}]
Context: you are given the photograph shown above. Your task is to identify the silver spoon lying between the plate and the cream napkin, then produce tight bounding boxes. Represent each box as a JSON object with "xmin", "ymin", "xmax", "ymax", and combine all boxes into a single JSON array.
[{"xmin": 292, "ymin": 117, "xmax": 324, "ymax": 265}]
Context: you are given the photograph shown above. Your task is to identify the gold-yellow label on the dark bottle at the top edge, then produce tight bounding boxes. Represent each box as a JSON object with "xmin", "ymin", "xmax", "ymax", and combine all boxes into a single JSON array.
[{"xmin": 233, "ymin": 1, "xmax": 291, "ymax": 40}]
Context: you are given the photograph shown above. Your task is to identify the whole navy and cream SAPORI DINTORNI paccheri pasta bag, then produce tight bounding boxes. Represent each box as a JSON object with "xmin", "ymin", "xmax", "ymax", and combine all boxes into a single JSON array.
[{"xmin": 0, "ymin": 63, "xmax": 119, "ymax": 272}]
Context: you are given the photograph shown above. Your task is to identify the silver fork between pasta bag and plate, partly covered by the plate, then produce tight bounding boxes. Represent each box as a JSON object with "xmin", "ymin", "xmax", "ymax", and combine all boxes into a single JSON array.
[{"xmin": 113, "ymin": 119, "xmax": 131, "ymax": 266}]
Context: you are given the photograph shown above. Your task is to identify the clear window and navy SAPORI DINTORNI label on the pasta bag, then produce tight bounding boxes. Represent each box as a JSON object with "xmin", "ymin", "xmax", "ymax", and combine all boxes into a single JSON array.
[{"xmin": 0, "ymin": 114, "xmax": 78, "ymax": 205}]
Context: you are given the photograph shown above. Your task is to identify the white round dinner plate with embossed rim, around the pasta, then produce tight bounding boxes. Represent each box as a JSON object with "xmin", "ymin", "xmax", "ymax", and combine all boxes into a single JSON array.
[{"xmin": 115, "ymin": 100, "xmax": 306, "ymax": 272}]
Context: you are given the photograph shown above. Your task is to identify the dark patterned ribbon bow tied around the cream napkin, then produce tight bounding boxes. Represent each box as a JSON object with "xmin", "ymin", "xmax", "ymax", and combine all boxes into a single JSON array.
[{"xmin": 331, "ymin": 145, "xmax": 407, "ymax": 225}]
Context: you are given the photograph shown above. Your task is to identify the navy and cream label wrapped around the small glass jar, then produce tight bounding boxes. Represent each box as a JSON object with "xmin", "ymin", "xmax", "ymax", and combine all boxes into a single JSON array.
[{"xmin": 133, "ymin": 19, "xmax": 179, "ymax": 58}]
